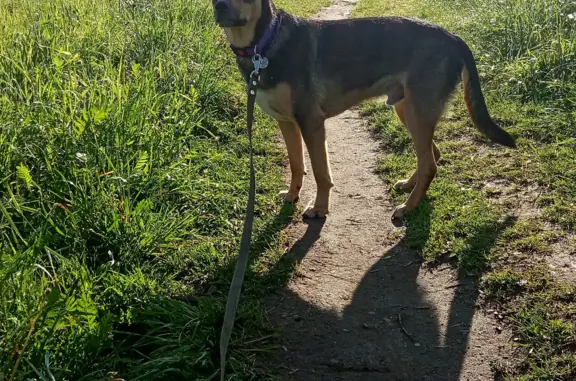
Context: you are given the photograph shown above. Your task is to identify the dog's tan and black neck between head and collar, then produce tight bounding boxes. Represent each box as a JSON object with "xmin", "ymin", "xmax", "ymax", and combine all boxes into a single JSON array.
[{"xmin": 224, "ymin": 0, "xmax": 276, "ymax": 48}]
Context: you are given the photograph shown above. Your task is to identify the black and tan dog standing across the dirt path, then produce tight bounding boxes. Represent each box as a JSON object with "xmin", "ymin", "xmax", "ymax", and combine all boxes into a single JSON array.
[{"xmin": 212, "ymin": 0, "xmax": 515, "ymax": 218}]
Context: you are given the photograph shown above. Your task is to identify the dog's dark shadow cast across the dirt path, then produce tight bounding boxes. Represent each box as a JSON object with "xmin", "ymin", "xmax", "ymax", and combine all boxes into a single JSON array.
[{"xmin": 258, "ymin": 202, "xmax": 514, "ymax": 381}]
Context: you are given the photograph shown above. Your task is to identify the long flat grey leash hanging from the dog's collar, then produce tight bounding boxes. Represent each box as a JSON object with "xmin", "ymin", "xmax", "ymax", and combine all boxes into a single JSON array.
[{"xmin": 220, "ymin": 54, "xmax": 268, "ymax": 381}]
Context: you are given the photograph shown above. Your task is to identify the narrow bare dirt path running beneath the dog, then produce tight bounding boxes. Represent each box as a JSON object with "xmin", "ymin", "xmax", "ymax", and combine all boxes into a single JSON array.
[{"xmin": 267, "ymin": 0, "xmax": 510, "ymax": 381}]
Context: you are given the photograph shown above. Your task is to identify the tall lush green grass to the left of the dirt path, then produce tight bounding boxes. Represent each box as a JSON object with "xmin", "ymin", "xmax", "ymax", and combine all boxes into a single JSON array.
[{"xmin": 0, "ymin": 0, "xmax": 325, "ymax": 381}]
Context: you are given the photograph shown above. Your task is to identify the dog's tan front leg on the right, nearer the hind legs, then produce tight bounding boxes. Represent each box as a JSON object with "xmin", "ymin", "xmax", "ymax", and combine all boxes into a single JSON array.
[{"xmin": 302, "ymin": 119, "xmax": 334, "ymax": 218}]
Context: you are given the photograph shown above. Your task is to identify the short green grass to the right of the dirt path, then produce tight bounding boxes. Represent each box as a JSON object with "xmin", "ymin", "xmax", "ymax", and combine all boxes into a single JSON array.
[{"xmin": 353, "ymin": 0, "xmax": 576, "ymax": 380}]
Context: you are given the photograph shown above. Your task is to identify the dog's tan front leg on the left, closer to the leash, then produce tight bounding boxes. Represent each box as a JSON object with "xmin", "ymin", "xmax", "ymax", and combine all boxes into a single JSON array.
[{"xmin": 278, "ymin": 121, "xmax": 306, "ymax": 202}]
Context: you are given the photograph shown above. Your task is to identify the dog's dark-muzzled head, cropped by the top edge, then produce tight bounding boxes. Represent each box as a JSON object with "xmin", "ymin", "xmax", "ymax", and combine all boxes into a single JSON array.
[{"xmin": 212, "ymin": 0, "xmax": 263, "ymax": 28}]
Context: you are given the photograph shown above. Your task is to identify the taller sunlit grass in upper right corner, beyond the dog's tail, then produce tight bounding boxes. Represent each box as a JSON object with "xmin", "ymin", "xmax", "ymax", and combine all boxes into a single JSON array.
[{"xmin": 467, "ymin": 0, "xmax": 576, "ymax": 111}]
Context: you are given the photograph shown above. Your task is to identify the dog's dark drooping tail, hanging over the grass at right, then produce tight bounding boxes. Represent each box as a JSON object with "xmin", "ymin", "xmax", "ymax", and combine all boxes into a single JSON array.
[{"xmin": 458, "ymin": 39, "xmax": 516, "ymax": 148}]
